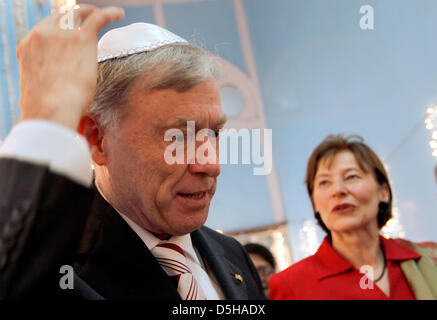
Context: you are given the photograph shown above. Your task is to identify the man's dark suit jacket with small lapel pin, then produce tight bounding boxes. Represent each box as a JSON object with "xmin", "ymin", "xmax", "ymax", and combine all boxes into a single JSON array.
[{"xmin": 0, "ymin": 159, "xmax": 265, "ymax": 300}]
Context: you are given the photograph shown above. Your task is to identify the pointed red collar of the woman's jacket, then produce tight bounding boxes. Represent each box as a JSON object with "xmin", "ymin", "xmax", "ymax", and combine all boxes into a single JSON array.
[{"xmin": 314, "ymin": 235, "xmax": 421, "ymax": 279}]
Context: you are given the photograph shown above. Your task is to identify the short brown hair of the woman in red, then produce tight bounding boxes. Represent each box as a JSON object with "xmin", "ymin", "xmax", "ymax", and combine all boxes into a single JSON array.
[{"xmin": 305, "ymin": 134, "xmax": 393, "ymax": 236}]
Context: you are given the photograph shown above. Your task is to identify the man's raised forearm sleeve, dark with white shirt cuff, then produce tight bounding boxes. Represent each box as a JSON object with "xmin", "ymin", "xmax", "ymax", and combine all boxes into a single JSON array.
[{"xmin": 0, "ymin": 121, "xmax": 93, "ymax": 299}]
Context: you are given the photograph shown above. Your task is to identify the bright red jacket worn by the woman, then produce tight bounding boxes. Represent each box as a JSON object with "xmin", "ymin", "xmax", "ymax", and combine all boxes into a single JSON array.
[{"xmin": 269, "ymin": 237, "xmax": 421, "ymax": 300}]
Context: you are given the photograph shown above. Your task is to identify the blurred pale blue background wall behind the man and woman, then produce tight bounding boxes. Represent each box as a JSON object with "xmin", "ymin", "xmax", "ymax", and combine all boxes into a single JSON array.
[{"xmin": 0, "ymin": 0, "xmax": 437, "ymax": 270}]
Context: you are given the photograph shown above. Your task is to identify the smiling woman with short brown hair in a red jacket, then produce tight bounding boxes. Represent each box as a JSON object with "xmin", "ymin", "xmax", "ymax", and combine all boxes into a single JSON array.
[{"xmin": 269, "ymin": 135, "xmax": 437, "ymax": 299}]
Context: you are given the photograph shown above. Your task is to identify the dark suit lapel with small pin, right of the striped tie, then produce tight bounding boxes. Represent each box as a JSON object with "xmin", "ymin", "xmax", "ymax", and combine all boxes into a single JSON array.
[{"xmin": 191, "ymin": 228, "xmax": 248, "ymax": 300}]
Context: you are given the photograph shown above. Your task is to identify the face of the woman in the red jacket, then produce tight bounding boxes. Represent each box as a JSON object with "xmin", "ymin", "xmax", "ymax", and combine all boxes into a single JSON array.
[{"xmin": 313, "ymin": 151, "xmax": 390, "ymax": 233}]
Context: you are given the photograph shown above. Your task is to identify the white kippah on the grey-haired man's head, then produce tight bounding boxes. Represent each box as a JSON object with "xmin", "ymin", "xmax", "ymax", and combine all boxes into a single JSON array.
[{"xmin": 97, "ymin": 23, "xmax": 188, "ymax": 62}]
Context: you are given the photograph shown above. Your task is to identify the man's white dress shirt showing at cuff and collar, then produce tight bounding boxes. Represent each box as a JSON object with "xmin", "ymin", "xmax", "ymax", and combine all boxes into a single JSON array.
[{"xmin": 0, "ymin": 119, "xmax": 225, "ymax": 300}]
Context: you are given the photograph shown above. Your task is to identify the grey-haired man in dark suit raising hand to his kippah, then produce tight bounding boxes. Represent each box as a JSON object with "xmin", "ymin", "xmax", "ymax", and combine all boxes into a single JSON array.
[{"xmin": 0, "ymin": 5, "xmax": 264, "ymax": 299}]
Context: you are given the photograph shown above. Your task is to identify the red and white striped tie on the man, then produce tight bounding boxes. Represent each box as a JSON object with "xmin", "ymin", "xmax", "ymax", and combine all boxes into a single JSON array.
[{"xmin": 152, "ymin": 242, "xmax": 206, "ymax": 300}]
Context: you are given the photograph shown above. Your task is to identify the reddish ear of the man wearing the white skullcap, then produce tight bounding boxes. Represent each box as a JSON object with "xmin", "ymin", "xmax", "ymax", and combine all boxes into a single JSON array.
[{"xmin": 77, "ymin": 112, "xmax": 107, "ymax": 166}]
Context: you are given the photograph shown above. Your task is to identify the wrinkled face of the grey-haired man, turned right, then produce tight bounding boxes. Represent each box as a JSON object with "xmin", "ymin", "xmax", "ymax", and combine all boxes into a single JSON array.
[{"xmin": 103, "ymin": 78, "xmax": 224, "ymax": 235}]
